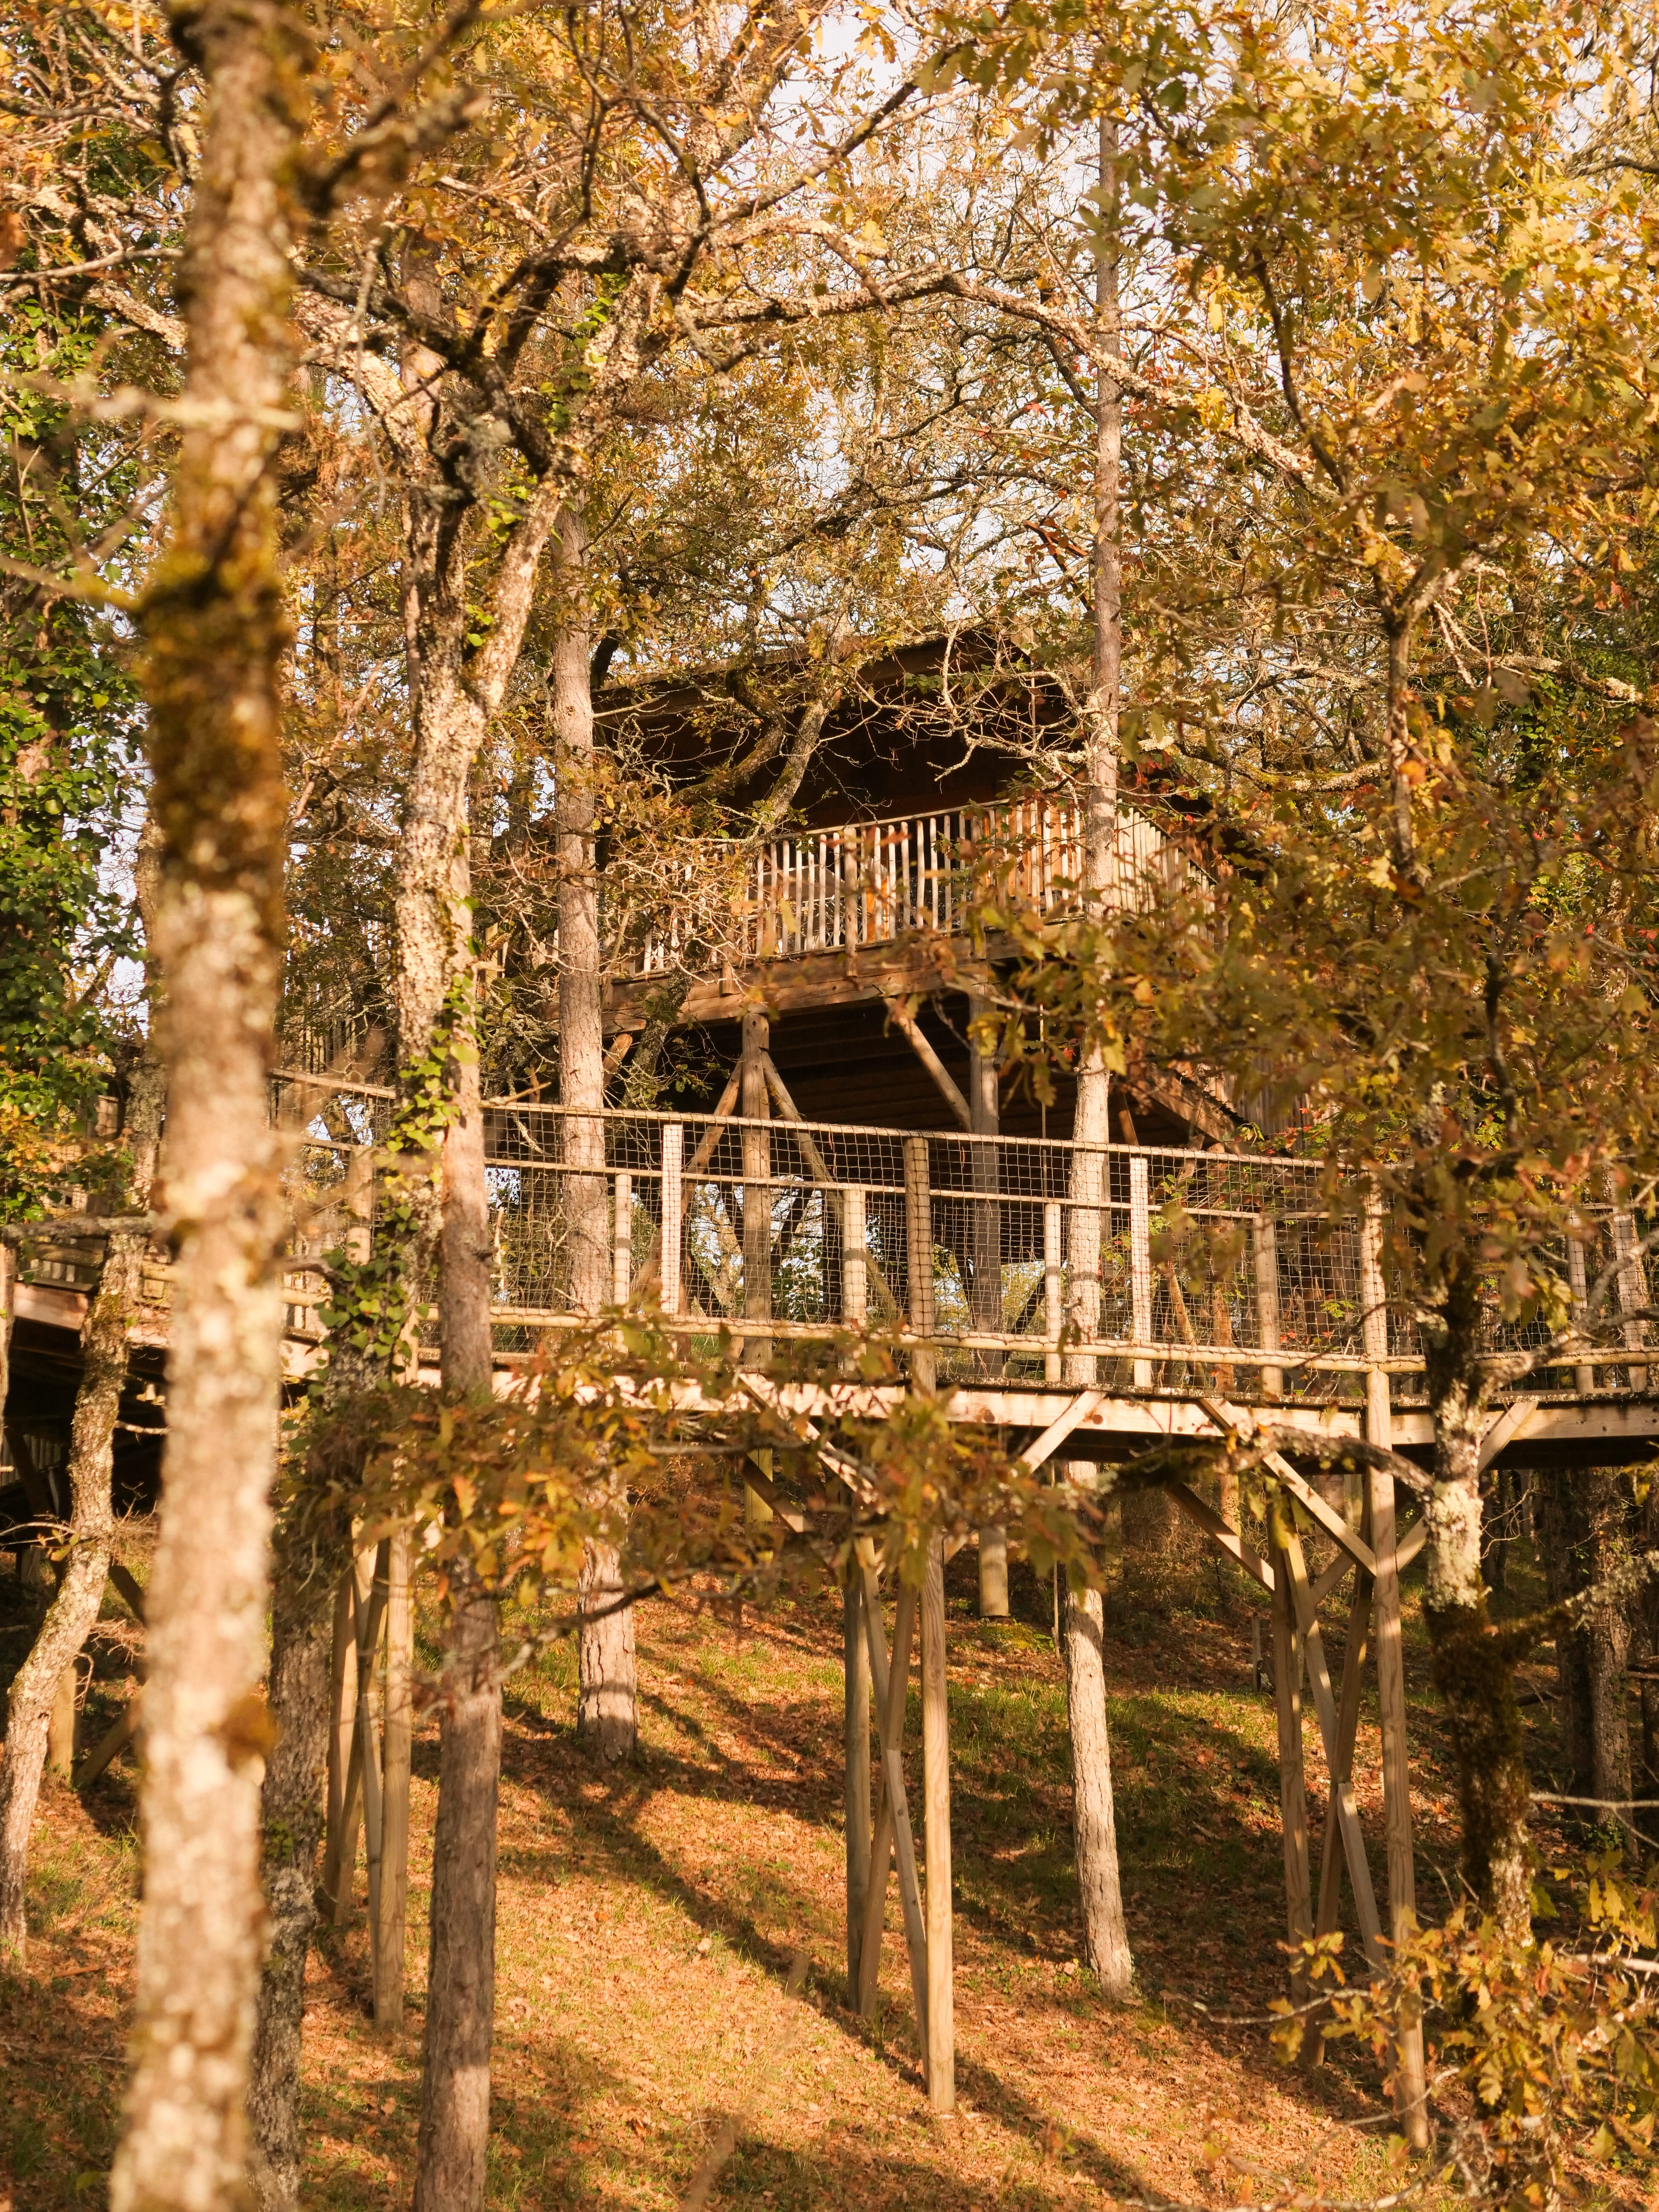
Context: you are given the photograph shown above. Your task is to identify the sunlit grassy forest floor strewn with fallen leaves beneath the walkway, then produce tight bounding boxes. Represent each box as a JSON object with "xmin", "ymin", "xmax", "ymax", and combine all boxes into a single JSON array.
[{"xmin": 0, "ymin": 1528, "xmax": 1555, "ymax": 2212}]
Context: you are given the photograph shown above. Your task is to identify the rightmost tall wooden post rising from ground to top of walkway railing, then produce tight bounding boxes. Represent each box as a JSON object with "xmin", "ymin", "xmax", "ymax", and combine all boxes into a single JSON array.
[{"xmin": 1360, "ymin": 1199, "xmax": 1429, "ymax": 2150}]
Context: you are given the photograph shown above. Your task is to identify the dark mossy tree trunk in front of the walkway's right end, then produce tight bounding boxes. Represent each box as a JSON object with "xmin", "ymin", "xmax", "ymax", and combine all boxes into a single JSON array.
[{"xmin": 1424, "ymin": 1270, "xmax": 1533, "ymax": 1942}]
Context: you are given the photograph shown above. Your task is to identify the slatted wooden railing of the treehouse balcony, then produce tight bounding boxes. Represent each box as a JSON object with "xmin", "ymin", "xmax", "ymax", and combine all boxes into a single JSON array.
[{"xmin": 635, "ymin": 794, "xmax": 1186, "ymax": 975}]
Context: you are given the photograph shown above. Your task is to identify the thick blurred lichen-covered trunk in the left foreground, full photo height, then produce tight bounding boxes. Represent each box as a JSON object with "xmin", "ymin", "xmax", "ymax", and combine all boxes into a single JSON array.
[{"xmin": 111, "ymin": 0, "xmax": 310, "ymax": 2212}]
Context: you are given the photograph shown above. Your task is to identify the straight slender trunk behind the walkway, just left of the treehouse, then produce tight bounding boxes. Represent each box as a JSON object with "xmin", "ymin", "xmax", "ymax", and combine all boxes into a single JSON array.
[{"xmin": 559, "ymin": 509, "xmax": 639, "ymax": 1765}]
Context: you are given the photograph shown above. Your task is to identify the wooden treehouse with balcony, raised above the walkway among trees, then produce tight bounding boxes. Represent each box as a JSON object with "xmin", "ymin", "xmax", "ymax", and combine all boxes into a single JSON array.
[{"xmin": 597, "ymin": 639, "xmax": 1241, "ymax": 1144}]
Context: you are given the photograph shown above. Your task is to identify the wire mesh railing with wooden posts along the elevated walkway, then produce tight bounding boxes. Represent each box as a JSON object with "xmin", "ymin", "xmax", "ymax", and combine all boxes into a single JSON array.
[{"xmin": 20, "ymin": 1077, "xmax": 1659, "ymax": 1403}]
